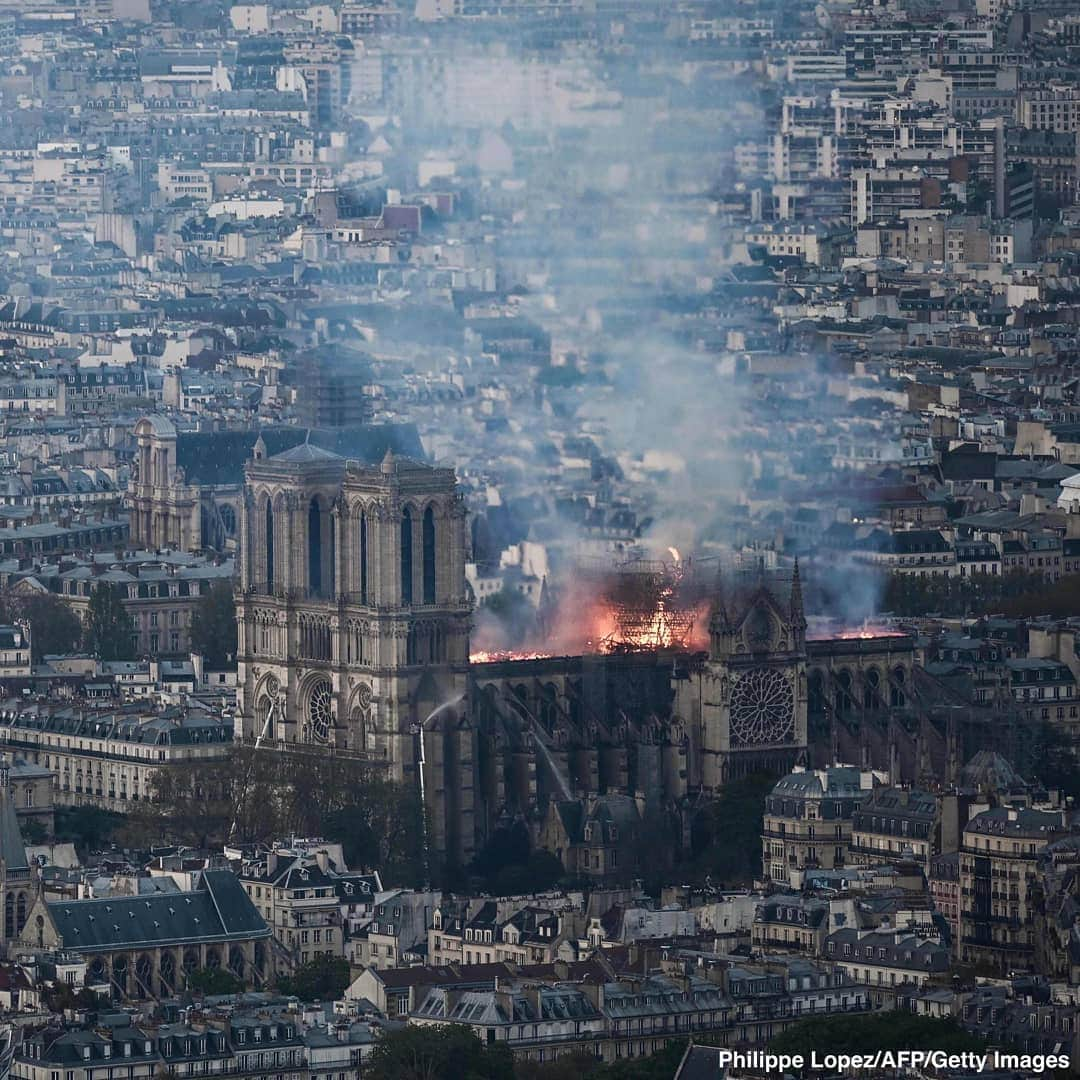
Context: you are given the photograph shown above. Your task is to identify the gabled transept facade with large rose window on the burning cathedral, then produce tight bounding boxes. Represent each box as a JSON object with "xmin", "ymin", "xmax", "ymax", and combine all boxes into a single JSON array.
[{"xmin": 700, "ymin": 563, "xmax": 807, "ymax": 791}]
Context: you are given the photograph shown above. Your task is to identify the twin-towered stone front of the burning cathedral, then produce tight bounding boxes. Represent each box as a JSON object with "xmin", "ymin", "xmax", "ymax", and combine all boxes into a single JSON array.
[{"xmin": 237, "ymin": 443, "xmax": 473, "ymax": 858}]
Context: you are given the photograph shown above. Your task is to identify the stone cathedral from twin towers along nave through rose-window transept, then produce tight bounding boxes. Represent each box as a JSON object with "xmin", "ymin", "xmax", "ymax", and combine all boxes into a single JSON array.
[{"xmin": 237, "ymin": 429, "xmax": 807, "ymax": 863}]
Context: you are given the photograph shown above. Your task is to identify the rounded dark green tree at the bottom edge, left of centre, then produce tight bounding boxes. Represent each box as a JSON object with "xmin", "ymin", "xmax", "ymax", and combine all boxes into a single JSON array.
[{"xmin": 365, "ymin": 1024, "xmax": 514, "ymax": 1080}]
